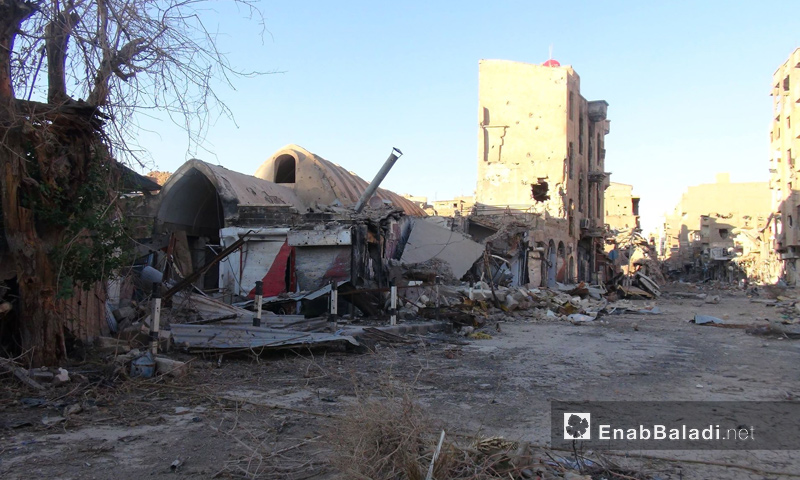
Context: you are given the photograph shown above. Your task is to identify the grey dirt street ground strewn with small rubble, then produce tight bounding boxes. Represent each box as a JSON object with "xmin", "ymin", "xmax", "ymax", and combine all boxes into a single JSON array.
[{"xmin": 0, "ymin": 285, "xmax": 800, "ymax": 480}]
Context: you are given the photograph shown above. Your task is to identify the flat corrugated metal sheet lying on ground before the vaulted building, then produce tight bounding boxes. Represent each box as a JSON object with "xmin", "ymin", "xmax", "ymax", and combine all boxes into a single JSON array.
[{"xmin": 170, "ymin": 324, "xmax": 358, "ymax": 351}]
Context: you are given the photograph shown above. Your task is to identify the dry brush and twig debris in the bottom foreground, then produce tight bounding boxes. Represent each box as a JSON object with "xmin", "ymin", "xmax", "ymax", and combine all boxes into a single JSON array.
[{"xmin": 328, "ymin": 386, "xmax": 651, "ymax": 480}]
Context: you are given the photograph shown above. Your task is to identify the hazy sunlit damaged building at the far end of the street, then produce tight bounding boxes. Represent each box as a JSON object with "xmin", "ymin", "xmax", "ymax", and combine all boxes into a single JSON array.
[{"xmin": 662, "ymin": 173, "xmax": 771, "ymax": 280}]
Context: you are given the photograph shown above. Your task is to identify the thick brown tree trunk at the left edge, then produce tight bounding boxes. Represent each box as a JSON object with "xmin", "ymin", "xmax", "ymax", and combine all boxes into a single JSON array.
[{"xmin": 0, "ymin": 0, "xmax": 76, "ymax": 366}]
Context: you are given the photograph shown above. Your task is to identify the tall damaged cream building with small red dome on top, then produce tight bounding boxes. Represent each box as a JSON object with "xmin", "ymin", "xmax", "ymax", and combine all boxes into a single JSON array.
[{"xmin": 469, "ymin": 59, "xmax": 610, "ymax": 286}]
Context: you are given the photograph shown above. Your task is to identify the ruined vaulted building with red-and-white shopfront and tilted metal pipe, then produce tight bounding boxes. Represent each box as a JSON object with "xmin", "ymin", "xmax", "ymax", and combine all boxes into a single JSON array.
[{"xmin": 146, "ymin": 145, "xmax": 483, "ymax": 315}]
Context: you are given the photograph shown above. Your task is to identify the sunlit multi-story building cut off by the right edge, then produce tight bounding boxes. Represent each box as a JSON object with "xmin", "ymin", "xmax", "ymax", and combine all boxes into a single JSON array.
[{"xmin": 768, "ymin": 48, "xmax": 800, "ymax": 284}]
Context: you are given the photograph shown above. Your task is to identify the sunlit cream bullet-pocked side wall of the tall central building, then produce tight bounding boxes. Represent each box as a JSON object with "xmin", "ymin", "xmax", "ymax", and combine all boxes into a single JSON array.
[{"xmin": 476, "ymin": 60, "xmax": 580, "ymax": 218}]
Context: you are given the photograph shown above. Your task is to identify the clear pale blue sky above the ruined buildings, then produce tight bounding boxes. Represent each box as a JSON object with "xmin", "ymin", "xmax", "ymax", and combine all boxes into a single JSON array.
[{"xmin": 139, "ymin": 0, "xmax": 800, "ymax": 232}]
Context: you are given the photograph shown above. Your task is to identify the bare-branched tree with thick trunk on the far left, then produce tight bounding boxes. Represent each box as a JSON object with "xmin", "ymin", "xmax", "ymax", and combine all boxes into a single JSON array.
[{"xmin": 0, "ymin": 0, "xmax": 260, "ymax": 365}]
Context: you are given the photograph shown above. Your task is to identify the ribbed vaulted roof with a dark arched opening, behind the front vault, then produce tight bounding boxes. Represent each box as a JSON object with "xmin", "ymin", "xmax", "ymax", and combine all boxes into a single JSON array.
[{"xmin": 255, "ymin": 145, "xmax": 427, "ymax": 217}]
